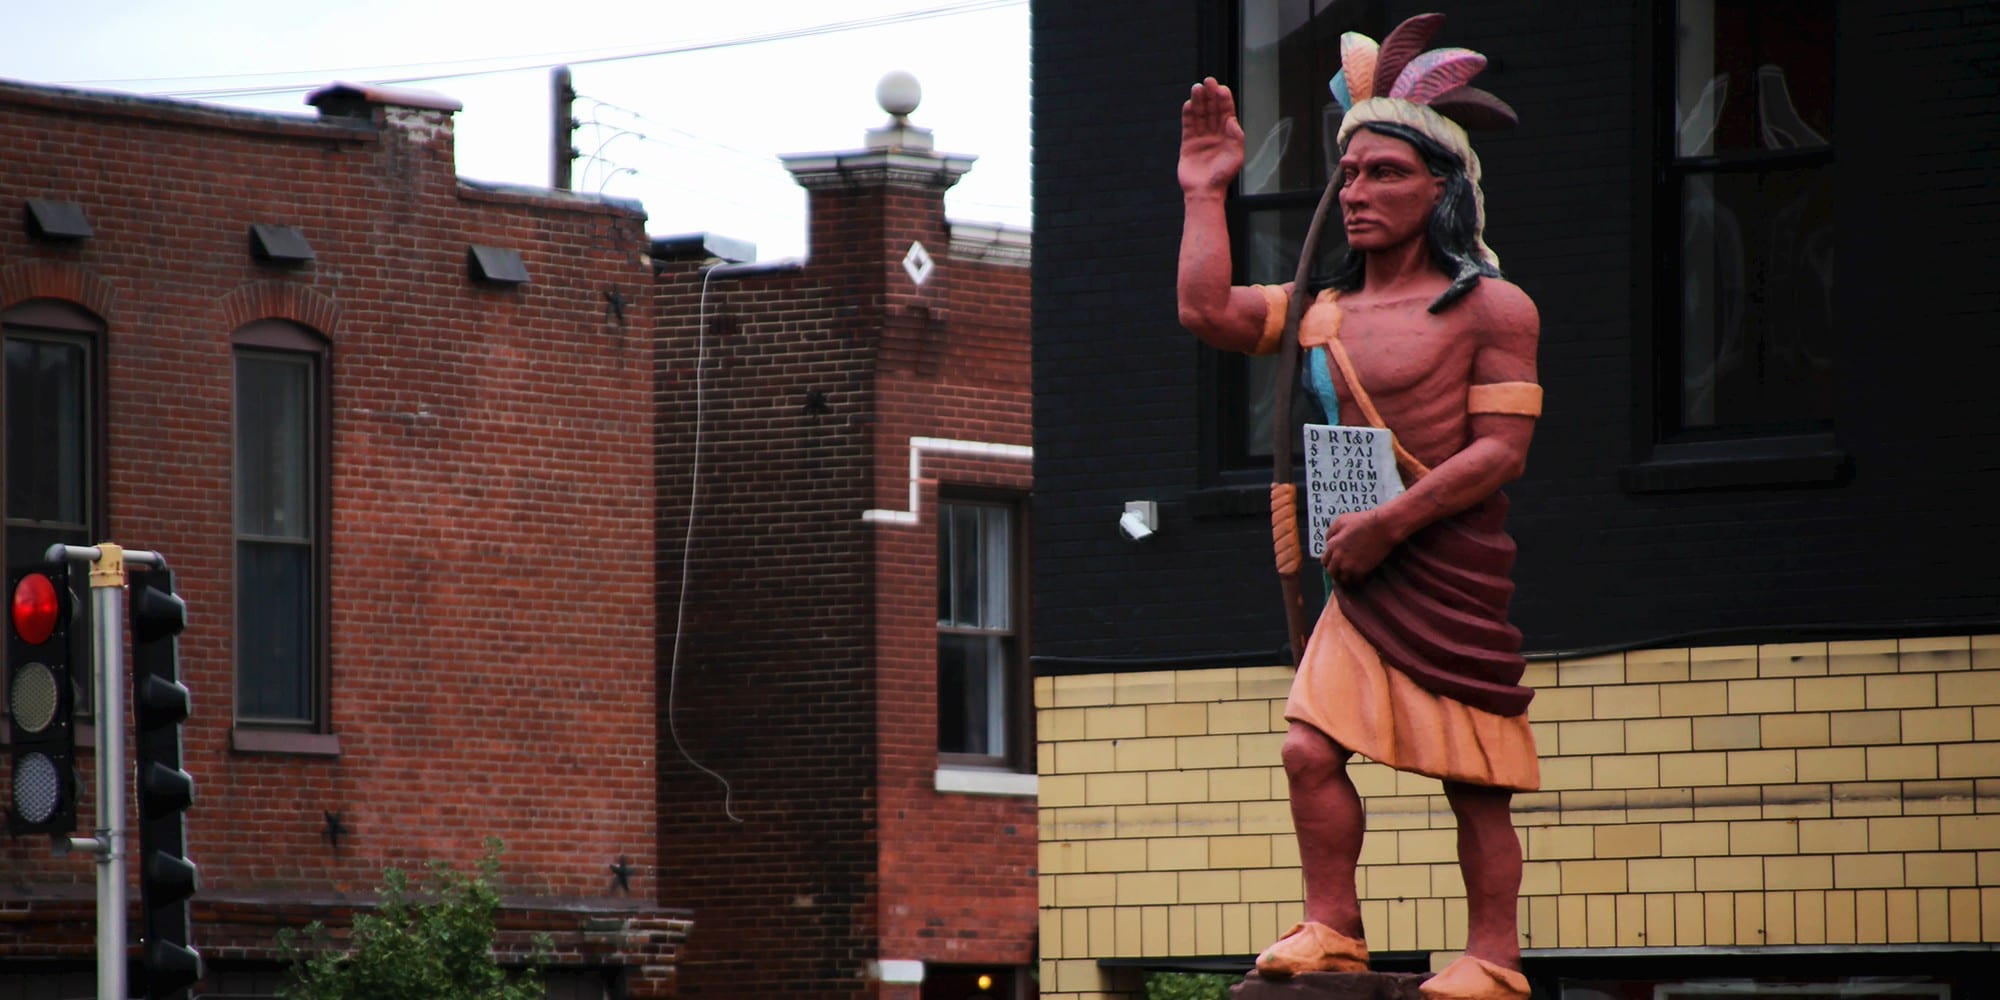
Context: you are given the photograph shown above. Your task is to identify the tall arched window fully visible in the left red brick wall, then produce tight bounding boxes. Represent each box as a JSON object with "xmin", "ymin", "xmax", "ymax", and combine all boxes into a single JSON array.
[{"xmin": 234, "ymin": 322, "xmax": 326, "ymax": 728}]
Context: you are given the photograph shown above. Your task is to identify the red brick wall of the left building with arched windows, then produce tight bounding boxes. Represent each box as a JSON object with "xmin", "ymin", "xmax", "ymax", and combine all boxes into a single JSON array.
[{"xmin": 0, "ymin": 76, "xmax": 672, "ymax": 984}]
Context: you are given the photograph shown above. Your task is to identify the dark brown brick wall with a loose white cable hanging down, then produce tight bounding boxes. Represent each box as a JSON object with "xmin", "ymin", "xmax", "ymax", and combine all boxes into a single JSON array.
[{"xmin": 656, "ymin": 248, "xmax": 874, "ymax": 996}]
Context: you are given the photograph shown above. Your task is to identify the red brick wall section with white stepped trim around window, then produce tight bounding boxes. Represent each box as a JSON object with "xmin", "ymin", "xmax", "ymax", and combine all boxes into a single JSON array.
[{"xmin": 876, "ymin": 234, "xmax": 1036, "ymax": 968}]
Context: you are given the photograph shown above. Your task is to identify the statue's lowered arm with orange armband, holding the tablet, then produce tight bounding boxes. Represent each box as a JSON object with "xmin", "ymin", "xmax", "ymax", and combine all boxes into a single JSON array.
[{"xmin": 1320, "ymin": 280, "xmax": 1542, "ymax": 582}]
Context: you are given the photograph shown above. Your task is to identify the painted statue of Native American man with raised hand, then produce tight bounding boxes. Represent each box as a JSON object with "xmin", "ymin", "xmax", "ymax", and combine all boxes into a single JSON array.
[{"xmin": 1178, "ymin": 14, "xmax": 1542, "ymax": 998}]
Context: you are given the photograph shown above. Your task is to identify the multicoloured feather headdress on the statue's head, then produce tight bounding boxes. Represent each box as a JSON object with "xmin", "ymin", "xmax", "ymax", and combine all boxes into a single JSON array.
[{"xmin": 1328, "ymin": 14, "xmax": 1518, "ymax": 268}]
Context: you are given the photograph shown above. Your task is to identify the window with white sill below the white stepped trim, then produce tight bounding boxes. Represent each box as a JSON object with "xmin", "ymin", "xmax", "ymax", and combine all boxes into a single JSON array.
[{"xmin": 938, "ymin": 502, "xmax": 1034, "ymax": 768}]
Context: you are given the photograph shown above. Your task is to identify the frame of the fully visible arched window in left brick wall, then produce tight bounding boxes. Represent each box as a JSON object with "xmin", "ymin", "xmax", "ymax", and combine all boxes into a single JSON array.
[{"xmin": 230, "ymin": 318, "xmax": 338, "ymax": 736}]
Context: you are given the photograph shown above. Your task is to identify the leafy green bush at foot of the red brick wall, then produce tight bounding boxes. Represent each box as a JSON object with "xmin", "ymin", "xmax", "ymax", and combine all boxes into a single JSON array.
[{"xmin": 278, "ymin": 838, "xmax": 548, "ymax": 1000}]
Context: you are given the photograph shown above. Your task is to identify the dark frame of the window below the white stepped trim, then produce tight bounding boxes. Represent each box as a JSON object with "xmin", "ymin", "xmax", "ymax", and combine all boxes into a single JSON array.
[{"xmin": 932, "ymin": 490, "xmax": 1036, "ymax": 774}]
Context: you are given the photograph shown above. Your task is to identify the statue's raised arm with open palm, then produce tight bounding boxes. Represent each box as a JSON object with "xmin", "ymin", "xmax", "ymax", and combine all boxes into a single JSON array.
[{"xmin": 1176, "ymin": 78, "xmax": 1268, "ymax": 352}]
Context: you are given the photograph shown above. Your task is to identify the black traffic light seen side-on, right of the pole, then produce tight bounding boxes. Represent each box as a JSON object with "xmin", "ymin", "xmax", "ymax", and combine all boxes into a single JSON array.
[{"xmin": 132, "ymin": 570, "xmax": 202, "ymax": 998}]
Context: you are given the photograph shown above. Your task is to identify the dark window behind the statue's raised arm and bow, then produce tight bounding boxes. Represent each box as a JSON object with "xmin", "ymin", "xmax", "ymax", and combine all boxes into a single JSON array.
[{"xmin": 1216, "ymin": 0, "xmax": 1382, "ymax": 470}]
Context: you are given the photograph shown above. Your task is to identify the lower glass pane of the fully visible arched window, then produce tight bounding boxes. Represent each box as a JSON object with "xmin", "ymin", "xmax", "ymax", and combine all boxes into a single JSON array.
[{"xmin": 236, "ymin": 542, "xmax": 316, "ymax": 722}]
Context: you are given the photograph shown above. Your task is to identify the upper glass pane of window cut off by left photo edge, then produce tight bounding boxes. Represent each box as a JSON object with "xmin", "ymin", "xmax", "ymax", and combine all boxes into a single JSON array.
[{"xmin": 6, "ymin": 336, "xmax": 90, "ymax": 532}]
